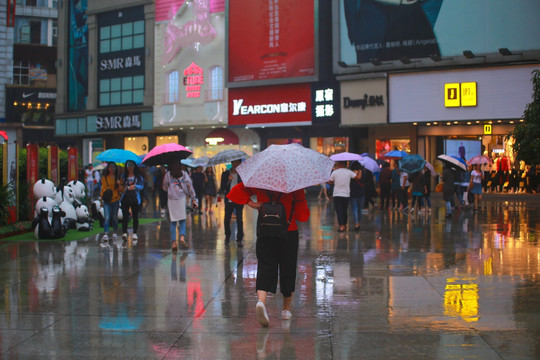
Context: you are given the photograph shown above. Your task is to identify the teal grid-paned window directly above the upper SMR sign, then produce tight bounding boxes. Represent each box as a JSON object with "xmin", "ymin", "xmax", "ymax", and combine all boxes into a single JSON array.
[{"xmin": 99, "ymin": 20, "xmax": 144, "ymax": 54}]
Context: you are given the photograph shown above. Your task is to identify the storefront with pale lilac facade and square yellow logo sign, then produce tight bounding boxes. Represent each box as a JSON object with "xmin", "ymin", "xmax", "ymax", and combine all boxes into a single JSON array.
[{"xmin": 388, "ymin": 65, "xmax": 539, "ymax": 166}]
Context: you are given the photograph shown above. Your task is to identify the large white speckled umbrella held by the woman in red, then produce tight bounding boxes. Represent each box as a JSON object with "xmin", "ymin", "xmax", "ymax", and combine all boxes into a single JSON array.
[{"xmin": 236, "ymin": 144, "xmax": 334, "ymax": 193}]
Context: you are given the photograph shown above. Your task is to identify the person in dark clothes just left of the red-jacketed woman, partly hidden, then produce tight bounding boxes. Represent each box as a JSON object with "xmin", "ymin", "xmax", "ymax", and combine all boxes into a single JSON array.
[{"xmin": 220, "ymin": 160, "xmax": 244, "ymax": 247}]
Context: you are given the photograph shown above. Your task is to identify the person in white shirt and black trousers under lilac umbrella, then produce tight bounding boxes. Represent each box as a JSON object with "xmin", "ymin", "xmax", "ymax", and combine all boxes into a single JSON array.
[{"xmin": 328, "ymin": 161, "xmax": 360, "ymax": 232}]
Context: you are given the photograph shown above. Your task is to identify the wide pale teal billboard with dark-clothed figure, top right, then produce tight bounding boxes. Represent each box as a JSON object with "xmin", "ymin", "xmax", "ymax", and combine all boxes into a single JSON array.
[{"xmin": 339, "ymin": 0, "xmax": 540, "ymax": 64}]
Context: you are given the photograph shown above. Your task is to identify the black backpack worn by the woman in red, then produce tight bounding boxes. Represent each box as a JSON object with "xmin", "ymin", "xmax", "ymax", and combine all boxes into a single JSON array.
[{"xmin": 257, "ymin": 192, "xmax": 294, "ymax": 239}]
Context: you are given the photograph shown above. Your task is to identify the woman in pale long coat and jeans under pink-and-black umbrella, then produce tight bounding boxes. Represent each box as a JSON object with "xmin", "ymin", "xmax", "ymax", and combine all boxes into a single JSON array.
[{"xmin": 162, "ymin": 162, "xmax": 199, "ymax": 252}]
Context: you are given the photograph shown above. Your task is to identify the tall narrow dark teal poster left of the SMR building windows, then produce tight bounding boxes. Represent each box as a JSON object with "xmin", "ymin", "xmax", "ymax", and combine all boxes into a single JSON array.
[{"xmin": 67, "ymin": 0, "xmax": 88, "ymax": 111}]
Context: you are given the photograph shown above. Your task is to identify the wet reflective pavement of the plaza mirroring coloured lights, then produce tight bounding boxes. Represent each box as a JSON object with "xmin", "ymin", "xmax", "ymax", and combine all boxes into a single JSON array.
[{"xmin": 0, "ymin": 194, "xmax": 540, "ymax": 359}]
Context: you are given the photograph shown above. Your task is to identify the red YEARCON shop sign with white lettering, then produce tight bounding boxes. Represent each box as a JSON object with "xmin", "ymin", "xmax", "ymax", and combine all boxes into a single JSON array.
[{"xmin": 229, "ymin": 84, "xmax": 312, "ymax": 127}]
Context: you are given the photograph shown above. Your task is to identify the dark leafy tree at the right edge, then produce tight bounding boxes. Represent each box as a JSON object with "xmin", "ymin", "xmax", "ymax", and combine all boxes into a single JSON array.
[{"xmin": 506, "ymin": 70, "xmax": 540, "ymax": 165}]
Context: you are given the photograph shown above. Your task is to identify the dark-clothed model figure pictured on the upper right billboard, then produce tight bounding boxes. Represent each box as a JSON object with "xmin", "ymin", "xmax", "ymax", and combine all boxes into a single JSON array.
[{"xmin": 343, "ymin": 0, "xmax": 443, "ymax": 64}]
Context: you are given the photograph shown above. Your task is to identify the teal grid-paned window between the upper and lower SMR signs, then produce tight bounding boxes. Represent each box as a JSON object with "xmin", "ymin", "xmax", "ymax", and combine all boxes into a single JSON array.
[{"xmin": 99, "ymin": 75, "xmax": 144, "ymax": 106}]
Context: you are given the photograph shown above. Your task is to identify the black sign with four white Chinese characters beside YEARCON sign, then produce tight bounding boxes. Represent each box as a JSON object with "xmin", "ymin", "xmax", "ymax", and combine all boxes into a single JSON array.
[{"xmin": 311, "ymin": 82, "xmax": 340, "ymax": 124}]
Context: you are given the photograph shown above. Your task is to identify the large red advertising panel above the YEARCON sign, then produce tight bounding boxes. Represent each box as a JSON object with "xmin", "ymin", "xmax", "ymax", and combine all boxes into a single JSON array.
[{"xmin": 228, "ymin": 0, "xmax": 316, "ymax": 87}]
